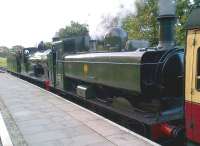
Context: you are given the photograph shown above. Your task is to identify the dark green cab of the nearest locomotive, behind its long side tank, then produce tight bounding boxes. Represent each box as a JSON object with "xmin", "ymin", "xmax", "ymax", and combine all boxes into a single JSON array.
[{"xmin": 48, "ymin": 34, "xmax": 90, "ymax": 90}]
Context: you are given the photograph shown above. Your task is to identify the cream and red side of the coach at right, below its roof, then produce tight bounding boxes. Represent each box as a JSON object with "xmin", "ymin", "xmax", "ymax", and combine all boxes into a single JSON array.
[{"xmin": 185, "ymin": 30, "xmax": 200, "ymax": 142}]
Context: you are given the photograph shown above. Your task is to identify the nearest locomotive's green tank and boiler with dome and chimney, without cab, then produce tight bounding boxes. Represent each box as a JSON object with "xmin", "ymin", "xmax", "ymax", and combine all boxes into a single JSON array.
[{"xmin": 64, "ymin": 1, "xmax": 184, "ymax": 112}]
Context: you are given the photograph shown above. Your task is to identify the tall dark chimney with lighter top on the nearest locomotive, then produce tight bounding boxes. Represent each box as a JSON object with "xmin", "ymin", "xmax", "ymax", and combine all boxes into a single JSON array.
[{"xmin": 158, "ymin": 0, "xmax": 176, "ymax": 50}]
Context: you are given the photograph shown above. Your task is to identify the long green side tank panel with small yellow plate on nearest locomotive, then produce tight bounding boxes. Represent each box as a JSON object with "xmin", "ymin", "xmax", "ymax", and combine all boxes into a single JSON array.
[{"xmin": 64, "ymin": 51, "xmax": 143, "ymax": 93}]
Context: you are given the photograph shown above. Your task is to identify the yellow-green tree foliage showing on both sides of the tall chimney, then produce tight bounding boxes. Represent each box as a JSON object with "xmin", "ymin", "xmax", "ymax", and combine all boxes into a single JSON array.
[{"xmin": 122, "ymin": 0, "xmax": 190, "ymax": 45}]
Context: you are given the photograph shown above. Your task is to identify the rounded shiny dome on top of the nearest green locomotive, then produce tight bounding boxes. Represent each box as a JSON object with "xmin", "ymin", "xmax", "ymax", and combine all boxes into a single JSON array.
[{"xmin": 104, "ymin": 27, "xmax": 128, "ymax": 51}]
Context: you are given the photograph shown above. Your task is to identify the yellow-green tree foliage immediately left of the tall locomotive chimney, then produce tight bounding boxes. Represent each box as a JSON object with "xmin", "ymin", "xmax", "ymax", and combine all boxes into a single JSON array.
[{"xmin": 122, "ymin": 0, "xmax": 158, "ymax": 45}]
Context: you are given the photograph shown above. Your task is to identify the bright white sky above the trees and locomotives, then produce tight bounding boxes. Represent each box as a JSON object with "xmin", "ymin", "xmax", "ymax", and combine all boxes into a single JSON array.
[{"xmin": 0, "ymin": 0, "xmax": 135, "ymax": 47}]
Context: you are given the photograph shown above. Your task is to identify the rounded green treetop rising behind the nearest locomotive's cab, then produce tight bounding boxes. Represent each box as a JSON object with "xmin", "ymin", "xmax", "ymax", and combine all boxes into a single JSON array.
[{"xmin": 57, "ymin": 21, "xmax": 89, "ymax": 38}]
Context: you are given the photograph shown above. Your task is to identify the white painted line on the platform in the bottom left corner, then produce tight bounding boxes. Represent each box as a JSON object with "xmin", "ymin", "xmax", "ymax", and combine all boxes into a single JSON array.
[{"xmin": 0, "ymin": 112, "xmax": 13, "ymax": 146}]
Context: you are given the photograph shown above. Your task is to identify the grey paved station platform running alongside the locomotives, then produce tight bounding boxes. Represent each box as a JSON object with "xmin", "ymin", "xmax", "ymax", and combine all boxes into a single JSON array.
[{"xmin": 0, "ymin": 73, "xmax": 158, "ymax": 146}]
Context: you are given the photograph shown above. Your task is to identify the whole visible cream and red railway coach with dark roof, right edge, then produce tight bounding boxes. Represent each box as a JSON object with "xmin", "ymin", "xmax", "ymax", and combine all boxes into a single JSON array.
[{"xmin": 185, "ymin": 4, "xmax": 200, "ymax": 146}]
